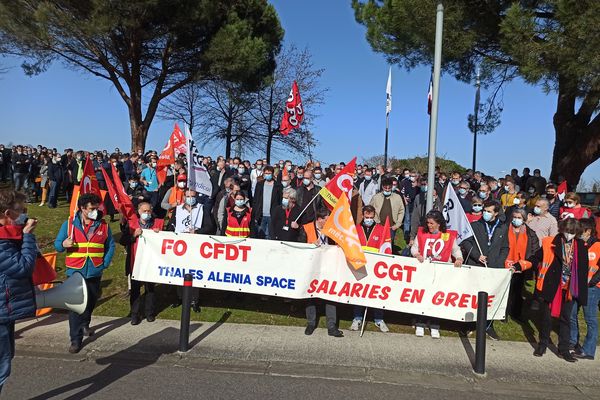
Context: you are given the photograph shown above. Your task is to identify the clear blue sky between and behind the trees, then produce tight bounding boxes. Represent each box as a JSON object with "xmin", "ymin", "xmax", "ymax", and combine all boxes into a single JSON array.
[{"xmin": 0, "ymin": 0, "xmax": 600, "ymax": 182}]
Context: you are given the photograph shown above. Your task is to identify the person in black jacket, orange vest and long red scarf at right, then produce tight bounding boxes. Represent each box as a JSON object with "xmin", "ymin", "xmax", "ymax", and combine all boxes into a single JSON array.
[{"xmin": 513, "ymin": 218, "xmax": 588, "ymax": 362}]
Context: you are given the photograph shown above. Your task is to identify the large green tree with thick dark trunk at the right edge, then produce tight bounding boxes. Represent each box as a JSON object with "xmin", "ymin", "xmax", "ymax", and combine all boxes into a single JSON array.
[{"xmin": 352, "ymin": 0, "xmax": 600, "ymax": 187}]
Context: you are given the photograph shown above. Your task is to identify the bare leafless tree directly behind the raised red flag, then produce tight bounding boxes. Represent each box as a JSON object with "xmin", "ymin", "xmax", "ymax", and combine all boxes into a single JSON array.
[{"xmin": 251, "ymin": 45, "xmax": 327, "ymax": 163}]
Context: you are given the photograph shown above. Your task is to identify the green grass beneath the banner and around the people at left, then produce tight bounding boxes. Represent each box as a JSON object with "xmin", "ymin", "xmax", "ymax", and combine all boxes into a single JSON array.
[{"xmin": 28, "ymin": 195, "xmax": 596, "ymax": 343}]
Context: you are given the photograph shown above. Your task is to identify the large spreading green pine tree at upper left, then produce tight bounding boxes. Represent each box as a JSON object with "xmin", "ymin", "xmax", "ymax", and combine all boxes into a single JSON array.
[{"xmin": 0, "ymin": 0, "xmax": 283, "ymax": 152}]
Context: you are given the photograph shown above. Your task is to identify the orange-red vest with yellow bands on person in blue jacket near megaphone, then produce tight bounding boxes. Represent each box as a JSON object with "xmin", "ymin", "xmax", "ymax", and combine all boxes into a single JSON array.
[{"xmin": 65, "ymin": 220, "xmax": 108, "ymax": 269}]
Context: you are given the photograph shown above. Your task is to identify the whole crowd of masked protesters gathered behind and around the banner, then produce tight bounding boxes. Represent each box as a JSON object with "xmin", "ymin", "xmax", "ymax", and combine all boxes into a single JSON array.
[{"xmin": 0, "ymin": 144, "xmax": 600, "ymax": 394}]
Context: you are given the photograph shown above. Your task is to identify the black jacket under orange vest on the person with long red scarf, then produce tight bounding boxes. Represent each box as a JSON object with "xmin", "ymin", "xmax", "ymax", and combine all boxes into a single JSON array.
[{"xmin": 527, "ymin": 234, "xmax": 589, "ymax": 306}]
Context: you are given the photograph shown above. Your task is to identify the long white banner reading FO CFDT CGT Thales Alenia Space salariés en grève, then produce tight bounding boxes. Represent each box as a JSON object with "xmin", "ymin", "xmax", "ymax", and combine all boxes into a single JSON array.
[{"xmin": 132, "ymin": 230, "xmax": 511, "ymax": 321}]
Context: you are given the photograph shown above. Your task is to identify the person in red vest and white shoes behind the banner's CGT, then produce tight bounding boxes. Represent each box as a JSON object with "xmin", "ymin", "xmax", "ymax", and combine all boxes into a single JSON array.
[{"xmin": 350, "ymin": 206, "xmax": 390, "ymax": 332}]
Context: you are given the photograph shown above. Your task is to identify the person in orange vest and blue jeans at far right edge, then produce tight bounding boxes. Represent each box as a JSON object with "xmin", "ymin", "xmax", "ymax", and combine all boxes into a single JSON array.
[{"xmin": 569, "ymin": 218, "xmax": 600, "ymax": 360}]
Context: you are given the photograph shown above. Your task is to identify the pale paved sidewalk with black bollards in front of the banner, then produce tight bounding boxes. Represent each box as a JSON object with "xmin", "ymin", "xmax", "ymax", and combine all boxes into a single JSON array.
[{"xmin": 16, "ymin": 314, "xmax": 600, "ymax": 398}]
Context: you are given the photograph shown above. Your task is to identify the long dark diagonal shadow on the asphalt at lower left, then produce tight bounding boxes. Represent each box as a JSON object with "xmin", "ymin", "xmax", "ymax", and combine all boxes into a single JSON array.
[{"xmin": 28, "ymin": 327, "xmax": 179, "ymax": 400}]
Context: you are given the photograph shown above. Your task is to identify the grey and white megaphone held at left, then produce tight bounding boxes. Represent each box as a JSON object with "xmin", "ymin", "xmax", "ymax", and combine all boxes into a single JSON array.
[{"xmin": 35, "ymin": 272, "xmax": 88, "ymax": 315}]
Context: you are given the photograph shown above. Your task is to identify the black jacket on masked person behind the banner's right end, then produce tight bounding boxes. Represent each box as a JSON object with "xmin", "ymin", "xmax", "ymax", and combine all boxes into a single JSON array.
[{"xmin": 460, "ymin": 216, "xmax": 509, "ymax": 268}]
